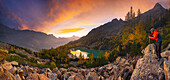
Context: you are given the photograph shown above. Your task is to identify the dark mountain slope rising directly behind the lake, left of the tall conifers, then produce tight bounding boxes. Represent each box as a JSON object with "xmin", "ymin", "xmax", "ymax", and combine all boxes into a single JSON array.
[{"xmin": 69, "ymin": 19, "xmax": 124, "ymax": 48}]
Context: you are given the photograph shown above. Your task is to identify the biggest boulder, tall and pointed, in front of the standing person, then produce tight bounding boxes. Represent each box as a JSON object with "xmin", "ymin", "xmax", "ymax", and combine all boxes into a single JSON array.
[{"xmin": 131, "ymin": 44, "xmax": 163, "ymax": 80}]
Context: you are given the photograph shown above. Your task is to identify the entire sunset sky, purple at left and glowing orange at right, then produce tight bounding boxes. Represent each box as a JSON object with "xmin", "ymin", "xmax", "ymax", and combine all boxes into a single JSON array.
[{"xmin": 0, "ymin": 0, "xmax": 170, "ymax": 37}]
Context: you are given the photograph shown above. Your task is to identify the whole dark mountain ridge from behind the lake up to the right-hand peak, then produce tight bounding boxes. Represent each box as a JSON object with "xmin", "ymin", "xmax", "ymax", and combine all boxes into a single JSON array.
[{"xmin": 69, "ymin": 3, "xmax": 166, "ymax": 49}]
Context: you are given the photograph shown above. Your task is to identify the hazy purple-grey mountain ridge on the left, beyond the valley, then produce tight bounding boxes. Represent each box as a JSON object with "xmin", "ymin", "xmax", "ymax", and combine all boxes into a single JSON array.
[{"xmin": 0, "ymin": 24, "xmax": 78, "ymax": 51}]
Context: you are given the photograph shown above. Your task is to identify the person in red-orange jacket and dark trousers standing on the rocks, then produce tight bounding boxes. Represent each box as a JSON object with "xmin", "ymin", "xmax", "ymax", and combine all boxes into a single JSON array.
[{"xmin": 149, "ymin": 28, "xmax": 162, "ymax": 61}]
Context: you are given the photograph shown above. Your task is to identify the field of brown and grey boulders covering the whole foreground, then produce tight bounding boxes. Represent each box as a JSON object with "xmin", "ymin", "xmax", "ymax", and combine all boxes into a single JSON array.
[{"xmin": 0, "ymin": 44, "xmax": 170, "ymax": 80}]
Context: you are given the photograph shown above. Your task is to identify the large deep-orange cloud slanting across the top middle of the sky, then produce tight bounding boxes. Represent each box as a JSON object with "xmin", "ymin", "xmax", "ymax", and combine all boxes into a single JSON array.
[{"xmin": 43, "ymin": 0, "xmax": 104, "ymax": 26}]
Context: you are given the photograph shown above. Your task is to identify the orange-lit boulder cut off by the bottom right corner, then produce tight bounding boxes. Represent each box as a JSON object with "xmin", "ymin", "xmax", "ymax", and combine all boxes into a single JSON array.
[{"xmin": 164, "ymin": 60, "xmax": 170, "ymax": 80}]
